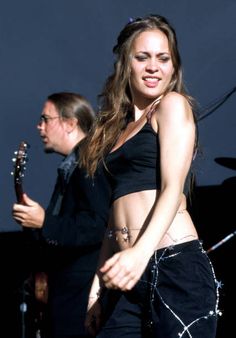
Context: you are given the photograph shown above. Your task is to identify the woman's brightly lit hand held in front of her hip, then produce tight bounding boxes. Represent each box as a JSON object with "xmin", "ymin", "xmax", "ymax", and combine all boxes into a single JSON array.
[{"xmin": 100, "ymin": 247, "xmax": 150, "ymax": 291}]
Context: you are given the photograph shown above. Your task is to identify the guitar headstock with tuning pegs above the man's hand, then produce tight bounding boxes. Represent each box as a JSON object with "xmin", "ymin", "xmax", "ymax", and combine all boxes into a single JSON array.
[{"xmin": 12, "ymin": 141, "xmax": 29, "ymax": 203}]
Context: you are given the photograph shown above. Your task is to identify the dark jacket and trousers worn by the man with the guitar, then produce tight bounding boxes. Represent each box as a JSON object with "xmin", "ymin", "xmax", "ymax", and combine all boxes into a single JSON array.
[{"xmin": 38, "ymin": 153, "xmax": 109, "ymax": 338}]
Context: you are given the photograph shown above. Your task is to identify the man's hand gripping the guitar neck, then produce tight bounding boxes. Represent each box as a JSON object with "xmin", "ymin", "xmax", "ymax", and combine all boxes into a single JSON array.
[{"xmin": 12, "ymin": 193, "xmax": 45, "ymax": 229}]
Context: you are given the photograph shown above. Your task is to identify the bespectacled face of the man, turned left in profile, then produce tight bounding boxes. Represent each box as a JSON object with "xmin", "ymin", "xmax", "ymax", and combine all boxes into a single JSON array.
[{"xmin": 37, "ymin": 101, "xmax": 66, "ymax": 153}]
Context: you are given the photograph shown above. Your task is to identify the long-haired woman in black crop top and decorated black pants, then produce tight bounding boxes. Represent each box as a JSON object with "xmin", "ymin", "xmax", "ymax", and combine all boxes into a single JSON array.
[{"xmin": 81, "ymin": 15, "xmax": 219, "ymax": 338}]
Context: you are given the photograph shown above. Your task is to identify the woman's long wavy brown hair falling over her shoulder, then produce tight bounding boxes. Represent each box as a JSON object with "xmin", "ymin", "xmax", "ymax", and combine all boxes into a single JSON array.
[{"xmin": 80, "ymin": 15, "xmax": 195, "ymax": 175}]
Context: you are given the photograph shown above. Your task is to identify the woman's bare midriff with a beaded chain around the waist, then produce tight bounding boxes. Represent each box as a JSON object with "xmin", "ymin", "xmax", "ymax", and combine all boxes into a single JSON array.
[{"xmin": 107, "ymin": 190, "xmax": 198, "ymax": 251}]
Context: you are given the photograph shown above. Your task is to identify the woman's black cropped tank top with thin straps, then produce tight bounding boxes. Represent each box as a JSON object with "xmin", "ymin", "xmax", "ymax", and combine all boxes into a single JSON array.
[{"xmin": 105, "ymin": 122, "xmax": 161, "ymax": 201}]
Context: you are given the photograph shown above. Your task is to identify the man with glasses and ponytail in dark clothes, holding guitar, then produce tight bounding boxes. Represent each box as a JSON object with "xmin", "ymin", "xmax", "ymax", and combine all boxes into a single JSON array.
[{"xmin": 13, "ymin": 92, "xmax": 109, "ymax": 338}]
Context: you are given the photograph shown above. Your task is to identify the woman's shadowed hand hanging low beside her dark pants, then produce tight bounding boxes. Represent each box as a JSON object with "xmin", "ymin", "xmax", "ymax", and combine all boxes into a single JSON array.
[{"xmin": 85, "ymin": 297, "xmax": 102, "ymax": 337}]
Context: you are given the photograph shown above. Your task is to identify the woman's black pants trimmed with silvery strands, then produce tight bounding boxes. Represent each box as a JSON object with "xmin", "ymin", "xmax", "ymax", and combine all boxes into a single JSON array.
[{"xmin": 97, "ymin": 240, "xmax": 218, "ymax": 338}]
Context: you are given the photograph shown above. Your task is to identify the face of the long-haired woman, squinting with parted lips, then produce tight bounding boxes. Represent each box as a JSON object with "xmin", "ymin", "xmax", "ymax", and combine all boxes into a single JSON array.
[{"xmin": 130, "ymin": 29, "xmax": 174, "ymax": 105}]
